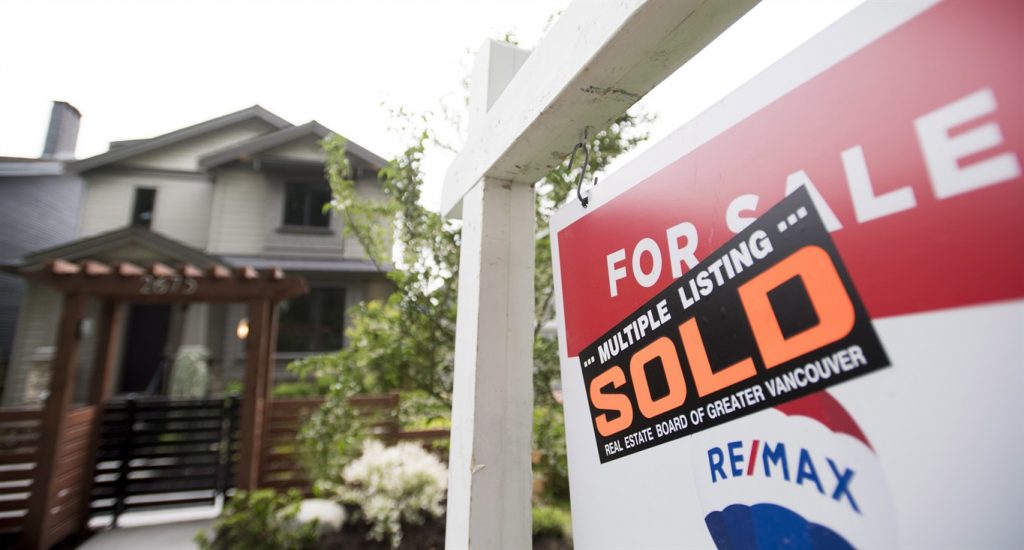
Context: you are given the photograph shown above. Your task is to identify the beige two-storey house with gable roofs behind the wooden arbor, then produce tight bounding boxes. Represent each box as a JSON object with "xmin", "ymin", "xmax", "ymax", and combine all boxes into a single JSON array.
[{"xmin": 3, "ymin": 105, "xmax": 391, "ymax": 405}]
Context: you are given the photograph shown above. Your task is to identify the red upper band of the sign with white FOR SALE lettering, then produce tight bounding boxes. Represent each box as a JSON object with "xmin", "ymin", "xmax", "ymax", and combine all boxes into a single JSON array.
[{"xmin": 557, "ymin": 1, "xmax": 1024, "ymax": 355}]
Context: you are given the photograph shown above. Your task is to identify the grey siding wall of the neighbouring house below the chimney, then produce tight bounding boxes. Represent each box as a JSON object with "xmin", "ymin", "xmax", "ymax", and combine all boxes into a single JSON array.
[{"xmin": 0, "ymin": 175, "xmax": 82, "ymax": 366}]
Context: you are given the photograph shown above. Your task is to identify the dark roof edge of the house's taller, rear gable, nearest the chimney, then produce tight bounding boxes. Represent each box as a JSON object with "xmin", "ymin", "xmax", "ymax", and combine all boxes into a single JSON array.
[{"xmin": 68, "ymin": 105, "xmax": 292, "ymax": 172}]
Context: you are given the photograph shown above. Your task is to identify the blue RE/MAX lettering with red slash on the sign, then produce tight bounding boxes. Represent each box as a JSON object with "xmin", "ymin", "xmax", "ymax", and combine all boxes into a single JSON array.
[{"xmin": 708, "ymin": 439, "xmax": 860, "ymax": 514}]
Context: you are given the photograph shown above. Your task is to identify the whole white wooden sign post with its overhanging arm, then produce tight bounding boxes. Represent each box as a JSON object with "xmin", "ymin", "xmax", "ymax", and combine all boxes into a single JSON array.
[{"xmin": 441, "ymin": 0, "xmax": 757, "ymax": 549}]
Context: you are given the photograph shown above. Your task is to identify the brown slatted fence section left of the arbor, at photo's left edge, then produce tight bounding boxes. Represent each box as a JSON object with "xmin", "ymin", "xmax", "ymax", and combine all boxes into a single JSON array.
[{"xmin": 0, "ymin": 409, "xmax": 43, "ymax": 540}]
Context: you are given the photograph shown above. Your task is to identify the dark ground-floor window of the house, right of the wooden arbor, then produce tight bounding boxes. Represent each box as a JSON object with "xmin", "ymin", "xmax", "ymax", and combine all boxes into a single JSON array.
[{"xmin": 278, "ymin": 288, "xmax": 345, "ymax": 352}]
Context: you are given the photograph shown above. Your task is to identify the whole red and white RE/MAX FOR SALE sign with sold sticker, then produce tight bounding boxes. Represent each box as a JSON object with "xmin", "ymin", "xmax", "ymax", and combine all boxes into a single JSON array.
[{"xmin": 552, "ymin": 0, "xmax": 1024, "ymax": 548}]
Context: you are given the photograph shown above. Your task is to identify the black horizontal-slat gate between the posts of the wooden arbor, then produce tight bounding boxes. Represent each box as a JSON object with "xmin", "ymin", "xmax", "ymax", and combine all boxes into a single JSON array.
[{"xmin": 91, "ymin": 397, "xmax": 239, "ymax": 524}]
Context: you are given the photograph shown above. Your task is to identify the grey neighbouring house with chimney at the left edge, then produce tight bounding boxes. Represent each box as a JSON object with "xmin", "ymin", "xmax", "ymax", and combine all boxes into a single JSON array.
[{"xmin": 0, "ymin": 101, "xmax": 82, "ymax": 395}]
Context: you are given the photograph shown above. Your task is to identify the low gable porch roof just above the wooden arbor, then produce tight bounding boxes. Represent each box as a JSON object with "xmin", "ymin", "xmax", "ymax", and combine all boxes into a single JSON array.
[{"xmin": 18, "ymin": 226, "xmax": 224, "ymax": 269}]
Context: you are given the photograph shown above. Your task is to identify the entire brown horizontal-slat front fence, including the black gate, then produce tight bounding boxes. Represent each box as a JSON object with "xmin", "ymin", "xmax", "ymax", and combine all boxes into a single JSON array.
[{"xmin": 0, "ymin": 393, "xmax": 449, "ymax": 547}]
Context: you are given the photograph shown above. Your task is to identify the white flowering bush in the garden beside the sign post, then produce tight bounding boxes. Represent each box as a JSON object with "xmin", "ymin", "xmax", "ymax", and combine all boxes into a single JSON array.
[{"xmin": 331, "ymin": 439, "xmax": 447, "ymax": 548}]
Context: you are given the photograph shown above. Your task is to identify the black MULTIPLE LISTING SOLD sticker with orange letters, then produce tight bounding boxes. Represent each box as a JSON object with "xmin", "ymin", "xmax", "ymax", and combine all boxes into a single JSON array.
[{"xmin": 580, "ymin": 188, "xmax": 889, "ymax": 463}]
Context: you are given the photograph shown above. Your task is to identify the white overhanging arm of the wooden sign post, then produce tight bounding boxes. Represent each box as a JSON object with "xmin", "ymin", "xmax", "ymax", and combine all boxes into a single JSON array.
[{"xmin": 441, "ymin": 0, "xmax": 758, "ymax": 215}]
